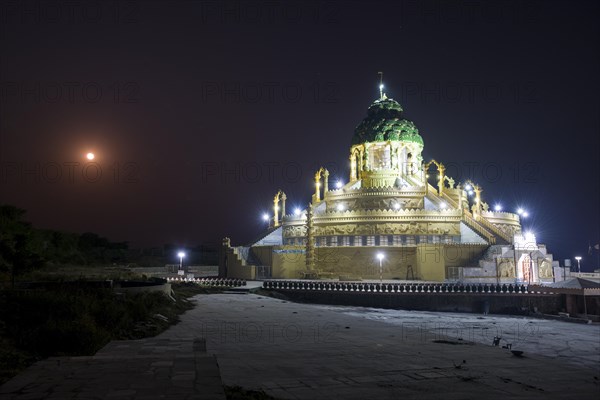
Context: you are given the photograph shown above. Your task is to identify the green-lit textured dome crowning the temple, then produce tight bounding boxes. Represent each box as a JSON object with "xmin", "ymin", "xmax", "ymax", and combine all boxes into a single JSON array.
[{"xmin": 352, "ymin": 96, "xmax": 423, "ymax": 145}]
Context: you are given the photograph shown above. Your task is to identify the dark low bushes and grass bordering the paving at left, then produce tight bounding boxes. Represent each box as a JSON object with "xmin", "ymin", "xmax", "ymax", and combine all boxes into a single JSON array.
[{"xmin": 0, "ymin": 281, "xmax": 204, "ymax": 385}]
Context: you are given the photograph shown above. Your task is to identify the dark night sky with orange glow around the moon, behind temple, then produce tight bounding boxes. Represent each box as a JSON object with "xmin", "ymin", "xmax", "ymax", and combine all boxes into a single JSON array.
[{"xmin": 0, "ymin": 0, "xmax": 600, "ymax": 271}]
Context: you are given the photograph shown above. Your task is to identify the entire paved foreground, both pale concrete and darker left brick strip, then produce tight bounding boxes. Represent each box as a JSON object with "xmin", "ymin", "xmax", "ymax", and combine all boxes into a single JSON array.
[{"xmin": 0, "ymin": 294, "xmax": 600, "ymax": 400}]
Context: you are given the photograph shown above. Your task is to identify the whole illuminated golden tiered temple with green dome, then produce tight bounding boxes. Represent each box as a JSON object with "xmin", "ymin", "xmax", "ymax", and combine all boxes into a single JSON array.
[{"xmin": 219, "ymin": 88, "xmax": 558, "ymax": 284}]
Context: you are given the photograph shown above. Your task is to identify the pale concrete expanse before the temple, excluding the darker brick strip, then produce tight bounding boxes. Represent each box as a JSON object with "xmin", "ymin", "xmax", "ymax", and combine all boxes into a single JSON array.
[{"xmin": 168, "ymin": 295, "xmax": 600, "ymax": 400}]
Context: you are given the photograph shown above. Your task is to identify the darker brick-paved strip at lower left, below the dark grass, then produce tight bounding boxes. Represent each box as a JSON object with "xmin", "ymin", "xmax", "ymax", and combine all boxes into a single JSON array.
[{"xmin": 0, "ymin": 338, "xmax": 225, "ymax": 400}]
